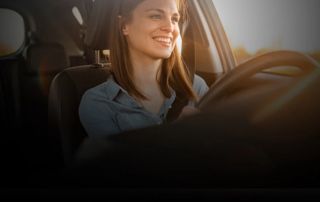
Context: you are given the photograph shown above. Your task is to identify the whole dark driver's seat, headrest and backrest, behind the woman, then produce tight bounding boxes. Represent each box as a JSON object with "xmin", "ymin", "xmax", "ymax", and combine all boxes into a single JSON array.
[{"xmin": 49, "ymin": 0, "xmax": 116, "ymax": 166}]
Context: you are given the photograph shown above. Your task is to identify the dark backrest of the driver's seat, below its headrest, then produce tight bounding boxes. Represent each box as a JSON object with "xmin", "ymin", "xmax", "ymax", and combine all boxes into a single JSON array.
[{"xmin": 49, "ymin": 65, "xmax": 110, "ymax": 165}]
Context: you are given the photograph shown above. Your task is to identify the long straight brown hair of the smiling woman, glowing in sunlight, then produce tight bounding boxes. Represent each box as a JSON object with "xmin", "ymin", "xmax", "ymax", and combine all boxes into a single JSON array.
[{"xmin": 110, "ymin": 0, "xmax": 197, "ymax": 100}]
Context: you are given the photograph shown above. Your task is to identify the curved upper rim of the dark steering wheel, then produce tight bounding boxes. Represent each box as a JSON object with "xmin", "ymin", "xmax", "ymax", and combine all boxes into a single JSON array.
[{"xmin": 197, "ymin": 50, "xmax": 319, "ymax": 110}]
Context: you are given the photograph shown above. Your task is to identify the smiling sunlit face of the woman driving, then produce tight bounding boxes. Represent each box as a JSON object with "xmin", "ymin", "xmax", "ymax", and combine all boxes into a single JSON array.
[{"xmin": 122, "ymin": 0, "xmax": 180, "ymax": 59}]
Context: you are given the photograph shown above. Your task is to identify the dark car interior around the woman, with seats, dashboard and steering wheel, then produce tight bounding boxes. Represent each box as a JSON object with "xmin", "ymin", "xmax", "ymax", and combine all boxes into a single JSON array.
[{"xmin": 0, "ymin": 0, "xmax": 320, "ymax": 199}]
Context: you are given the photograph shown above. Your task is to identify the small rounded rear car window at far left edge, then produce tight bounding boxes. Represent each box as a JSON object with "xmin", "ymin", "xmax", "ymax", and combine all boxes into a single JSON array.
[{"xmin": 0, "ymin": 8, "xmax": 25, "ymax": 57}]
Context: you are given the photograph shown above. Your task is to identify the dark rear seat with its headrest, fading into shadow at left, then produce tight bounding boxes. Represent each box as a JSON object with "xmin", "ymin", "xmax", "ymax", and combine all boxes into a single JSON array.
[{"xmin": 20, "ymin": 42, "xmax": 69, "ymax": 170}]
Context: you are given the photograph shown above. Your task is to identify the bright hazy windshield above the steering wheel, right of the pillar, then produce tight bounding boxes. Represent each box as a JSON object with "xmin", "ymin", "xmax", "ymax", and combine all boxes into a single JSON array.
[{"xmin": 212, "ymin": 0, "xmax": 320, "ymax": 64}]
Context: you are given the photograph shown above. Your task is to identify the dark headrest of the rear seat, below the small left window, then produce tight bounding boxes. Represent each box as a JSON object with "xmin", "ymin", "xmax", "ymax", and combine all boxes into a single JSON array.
[{"xmin": 26, "ymin": 43, "xmax": 69, "ymax": 73}]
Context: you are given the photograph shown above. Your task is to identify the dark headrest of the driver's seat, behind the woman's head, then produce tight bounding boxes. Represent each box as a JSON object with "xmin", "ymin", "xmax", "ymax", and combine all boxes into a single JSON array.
[{"xmin": 85, "ymin": 0, "xmax": 117, "ymax": 50}]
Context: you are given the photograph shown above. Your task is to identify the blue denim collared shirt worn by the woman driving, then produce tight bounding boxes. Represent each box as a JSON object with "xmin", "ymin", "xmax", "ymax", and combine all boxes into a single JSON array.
[{"xmin": 79, "ymin": 75, "xmax": 208, "ymax": 138}]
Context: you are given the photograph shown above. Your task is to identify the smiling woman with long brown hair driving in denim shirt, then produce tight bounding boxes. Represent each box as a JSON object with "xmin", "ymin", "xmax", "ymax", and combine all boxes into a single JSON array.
[{"xmin": 79, "ymin": 0, "xmax": 208, "ymax": 138}]
